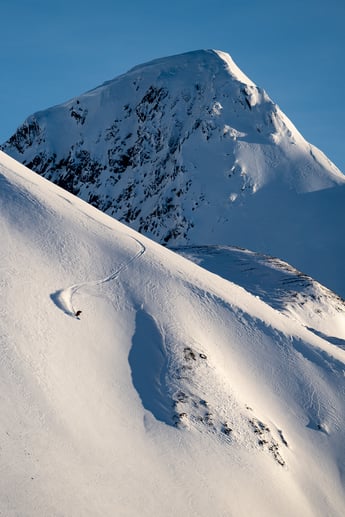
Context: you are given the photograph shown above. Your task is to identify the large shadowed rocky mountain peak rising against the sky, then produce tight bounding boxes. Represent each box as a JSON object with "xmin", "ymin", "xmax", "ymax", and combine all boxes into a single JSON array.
[{"xmin": 2, "ymin": 50, "xmax": 345, "ymax": 296}]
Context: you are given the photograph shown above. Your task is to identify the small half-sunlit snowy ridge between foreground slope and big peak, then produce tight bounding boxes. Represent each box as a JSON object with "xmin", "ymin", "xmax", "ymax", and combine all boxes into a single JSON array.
[{"xmin": 176, "ymin": 246, "xmax": 345, "ymax": 349}]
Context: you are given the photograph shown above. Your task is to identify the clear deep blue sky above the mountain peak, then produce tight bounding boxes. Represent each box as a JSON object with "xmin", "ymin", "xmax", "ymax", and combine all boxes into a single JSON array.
[{"xmin": 0, "ymin": 0, "xmax": 345, "ymax": 172}]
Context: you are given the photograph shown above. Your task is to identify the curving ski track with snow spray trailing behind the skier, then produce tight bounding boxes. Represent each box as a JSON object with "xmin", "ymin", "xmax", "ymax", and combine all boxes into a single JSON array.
[{"xmin": 50, "ymin": 236, "xmax": 146, "ymax": 317}]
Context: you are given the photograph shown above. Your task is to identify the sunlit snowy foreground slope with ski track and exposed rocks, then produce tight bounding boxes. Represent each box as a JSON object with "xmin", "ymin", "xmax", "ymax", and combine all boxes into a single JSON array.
[{"xmin": 0, "ymin": 153, "xmax": 345, "ymax": 517}]
